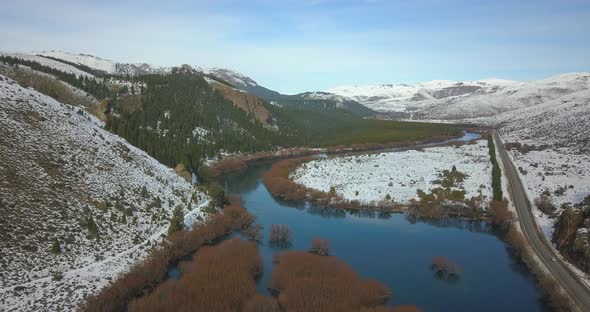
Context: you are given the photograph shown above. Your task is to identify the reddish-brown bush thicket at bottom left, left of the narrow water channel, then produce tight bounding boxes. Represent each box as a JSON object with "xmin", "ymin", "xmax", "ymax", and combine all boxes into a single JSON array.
[{"xmin": 129, "ymin": 238, "xmax": 262, "ymax": 312}]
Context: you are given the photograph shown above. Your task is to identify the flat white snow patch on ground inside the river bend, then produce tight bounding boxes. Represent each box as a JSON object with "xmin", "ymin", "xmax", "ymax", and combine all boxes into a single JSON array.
[{"xmin": 291, "ymin": 140, "xmax": 492, "ymax": 203}]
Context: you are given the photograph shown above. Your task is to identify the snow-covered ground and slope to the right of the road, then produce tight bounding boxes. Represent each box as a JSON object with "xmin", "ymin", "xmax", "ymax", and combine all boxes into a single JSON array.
[{"xmin": 486, "ymin": 89, "xmax": 590, "ymax": 238}]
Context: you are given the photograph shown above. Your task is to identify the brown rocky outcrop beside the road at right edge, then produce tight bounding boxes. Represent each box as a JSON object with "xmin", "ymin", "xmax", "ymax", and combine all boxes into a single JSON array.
[{"xmin": 552, "ymin": 209, "xmax": 590, "ymax": 272}]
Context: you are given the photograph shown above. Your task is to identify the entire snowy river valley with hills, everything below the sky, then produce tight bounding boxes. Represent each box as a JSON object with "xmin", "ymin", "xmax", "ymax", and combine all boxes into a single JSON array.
[{"xmin": 0, "ymin": 51, "xmax": 590, "ymax": 311}]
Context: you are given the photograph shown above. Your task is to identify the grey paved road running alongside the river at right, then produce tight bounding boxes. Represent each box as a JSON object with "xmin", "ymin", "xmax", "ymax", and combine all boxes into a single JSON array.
[{"xmin": 494, "ymin": 132, "xmax": 590, "ymax": 311}]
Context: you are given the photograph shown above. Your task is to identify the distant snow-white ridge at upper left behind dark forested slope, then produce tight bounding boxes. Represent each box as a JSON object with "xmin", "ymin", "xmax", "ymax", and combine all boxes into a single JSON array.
[{"xmin": 34, "ymin": 51, "xmax": 170, "ymax": 75}]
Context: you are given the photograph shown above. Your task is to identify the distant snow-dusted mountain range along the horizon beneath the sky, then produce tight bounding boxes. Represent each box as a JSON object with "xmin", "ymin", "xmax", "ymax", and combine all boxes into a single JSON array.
[{"xmin": 4, "ymin": 51, "xmax": 590, "ymax": 120}]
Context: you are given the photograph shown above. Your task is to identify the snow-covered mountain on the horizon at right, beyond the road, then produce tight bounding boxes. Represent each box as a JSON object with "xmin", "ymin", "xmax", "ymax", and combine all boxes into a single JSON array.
[{"xmin": 327, "ymin": 72, "xmax": 590, "ymax": 119}]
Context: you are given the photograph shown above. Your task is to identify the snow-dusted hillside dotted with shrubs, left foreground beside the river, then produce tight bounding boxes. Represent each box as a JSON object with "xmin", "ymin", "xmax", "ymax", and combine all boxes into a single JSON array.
[{"xmin": 0, "ymin": 75, "xmax": 207, "ymax": 311}]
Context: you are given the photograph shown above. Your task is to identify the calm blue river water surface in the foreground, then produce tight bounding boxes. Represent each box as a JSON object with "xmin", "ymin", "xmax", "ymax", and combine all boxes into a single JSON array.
[{"xmin": 222, "ymin": 157, "xmax": 548, "ymax": 311}]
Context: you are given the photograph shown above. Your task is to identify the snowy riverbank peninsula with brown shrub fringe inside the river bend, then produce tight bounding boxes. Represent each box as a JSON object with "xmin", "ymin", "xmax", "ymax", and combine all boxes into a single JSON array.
[{"xmin": 263, "ymin": 133, "xmax": 500, "ymax": 220}]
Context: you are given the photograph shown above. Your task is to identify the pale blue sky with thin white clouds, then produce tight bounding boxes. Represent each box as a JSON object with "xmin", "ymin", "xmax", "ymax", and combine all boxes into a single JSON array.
[{"xmin": 0, "ymin": 0, "xmax": 590, "ymax": 93}]
